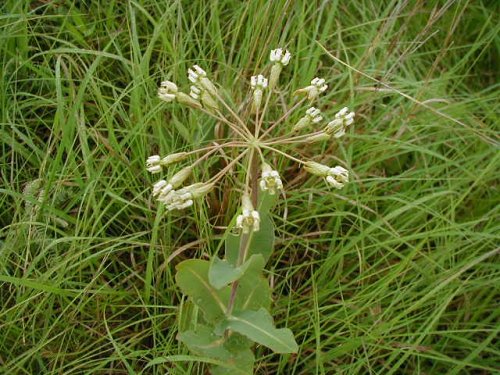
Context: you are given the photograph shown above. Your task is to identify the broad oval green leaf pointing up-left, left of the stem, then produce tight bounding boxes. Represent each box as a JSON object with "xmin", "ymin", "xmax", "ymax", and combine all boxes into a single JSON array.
[{"xmin": 175, "ymin": 259, "xmax": 230, "ymax": 321}]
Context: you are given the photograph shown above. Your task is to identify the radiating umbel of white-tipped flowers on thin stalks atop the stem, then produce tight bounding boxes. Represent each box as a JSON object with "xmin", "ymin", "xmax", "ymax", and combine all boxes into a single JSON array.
[{"xmin": 146, "ymin": 48, "xmax": 354, "ymax": 233}]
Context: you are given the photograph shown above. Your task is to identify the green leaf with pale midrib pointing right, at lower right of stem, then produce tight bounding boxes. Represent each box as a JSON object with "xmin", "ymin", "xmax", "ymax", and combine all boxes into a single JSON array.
[{"xmin": 225, "ymin": 308, "xmax": 299, "ymax": 353}]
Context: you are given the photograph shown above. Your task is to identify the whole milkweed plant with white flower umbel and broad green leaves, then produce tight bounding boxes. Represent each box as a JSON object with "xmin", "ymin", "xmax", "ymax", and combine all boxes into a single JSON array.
[{"xmin": 146, "ymin": 48, "xmax": 354, "ymax": 375}]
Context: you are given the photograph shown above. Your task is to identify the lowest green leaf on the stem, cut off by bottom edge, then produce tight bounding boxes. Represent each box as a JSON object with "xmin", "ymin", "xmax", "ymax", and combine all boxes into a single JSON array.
[{"xmin": 178, "ymin": 325, "xmax": 255, "ymax": 375}]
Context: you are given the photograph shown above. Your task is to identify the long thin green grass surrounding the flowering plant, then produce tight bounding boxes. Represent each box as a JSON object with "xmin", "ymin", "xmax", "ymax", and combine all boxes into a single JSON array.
[{"xmin": 0, "ymin": 0, "xmax": 500, "ymax": 375}]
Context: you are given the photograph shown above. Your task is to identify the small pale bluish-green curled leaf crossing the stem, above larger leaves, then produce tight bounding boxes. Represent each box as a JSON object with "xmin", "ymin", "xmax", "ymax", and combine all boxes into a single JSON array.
[{"xmin": 208, "ymin": 254, "xmax": 264, "ymax": 289}]
